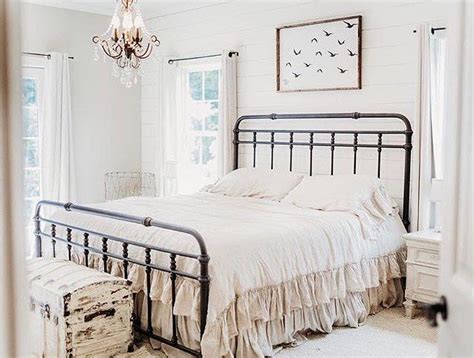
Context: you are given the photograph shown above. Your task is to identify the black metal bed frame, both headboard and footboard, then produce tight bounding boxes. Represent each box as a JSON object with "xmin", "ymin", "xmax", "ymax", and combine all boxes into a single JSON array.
[{"xmin": 34, "ymin": 112, "xmax": 413, "ymax": 357}]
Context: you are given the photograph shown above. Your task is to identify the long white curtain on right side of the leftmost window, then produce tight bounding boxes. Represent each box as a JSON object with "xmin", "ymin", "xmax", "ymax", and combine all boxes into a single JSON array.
[{"xmin": 40, "ymin": 53, "xmax": 75, "ymax": 201}]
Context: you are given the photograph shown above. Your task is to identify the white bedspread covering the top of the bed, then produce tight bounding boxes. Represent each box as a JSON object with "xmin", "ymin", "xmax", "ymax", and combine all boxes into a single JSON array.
[{"xmin": 49, "ymin": 193, "xmax": 405, "ymax": 356}]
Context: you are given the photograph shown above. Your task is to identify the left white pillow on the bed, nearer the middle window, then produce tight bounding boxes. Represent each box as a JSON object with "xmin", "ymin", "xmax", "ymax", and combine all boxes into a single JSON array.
[{"xmin": 205, "ymin": 168, "xmax": 303, "ymax": 200}]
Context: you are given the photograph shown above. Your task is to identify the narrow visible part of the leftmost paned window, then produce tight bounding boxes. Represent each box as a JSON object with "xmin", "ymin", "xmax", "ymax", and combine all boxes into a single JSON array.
[{"xmin": 21, "ymin": 65, "xmax": 44, "ymax": 241}]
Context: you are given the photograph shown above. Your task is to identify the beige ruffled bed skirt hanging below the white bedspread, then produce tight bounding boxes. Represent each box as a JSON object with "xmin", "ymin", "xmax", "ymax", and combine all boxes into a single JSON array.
[{"xmin": 63, "ymin": 250, "xmax": 406, "ymax": 358}]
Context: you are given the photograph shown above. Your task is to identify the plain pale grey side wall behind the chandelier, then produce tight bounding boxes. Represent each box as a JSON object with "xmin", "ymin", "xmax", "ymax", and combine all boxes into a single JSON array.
[{"xmin": 21, "ymin": 4, "xmax": 141, "ymax": 203}]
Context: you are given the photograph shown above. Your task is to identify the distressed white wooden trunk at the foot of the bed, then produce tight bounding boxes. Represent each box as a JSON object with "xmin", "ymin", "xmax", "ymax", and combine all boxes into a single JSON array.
[{"xmin": 27, "ymin": 258, "xmax": 133, "ymax": 357}]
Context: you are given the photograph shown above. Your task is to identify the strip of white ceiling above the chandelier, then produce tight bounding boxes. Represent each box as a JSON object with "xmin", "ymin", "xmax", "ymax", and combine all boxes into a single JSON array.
[{"xmin": 23, "ymin": 0, "xmax": 229, "ymax": 19}]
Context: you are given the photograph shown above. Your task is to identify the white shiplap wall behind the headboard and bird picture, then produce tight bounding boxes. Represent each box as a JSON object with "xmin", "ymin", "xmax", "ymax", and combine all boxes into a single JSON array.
[{"xmin": 142, "ymin": 1, "xmax": 450, "ymax": 227}]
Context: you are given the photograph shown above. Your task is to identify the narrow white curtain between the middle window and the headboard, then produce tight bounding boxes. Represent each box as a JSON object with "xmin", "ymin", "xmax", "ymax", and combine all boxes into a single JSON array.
[{"xmin": 217, "ymin": 50, "xmax": 237, "ymax": 177}]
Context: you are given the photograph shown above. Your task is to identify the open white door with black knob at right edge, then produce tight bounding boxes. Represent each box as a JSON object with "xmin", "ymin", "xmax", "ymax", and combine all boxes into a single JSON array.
[{"xmin": 438, "ymin": 1, "xmax": 474, "ymax": 357}]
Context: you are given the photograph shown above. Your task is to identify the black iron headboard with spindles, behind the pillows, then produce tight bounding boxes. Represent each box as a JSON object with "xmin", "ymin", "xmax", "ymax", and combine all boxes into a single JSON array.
[{"xmin": 233, "ymin": 112, "xmax": 413, "ymax": 230}]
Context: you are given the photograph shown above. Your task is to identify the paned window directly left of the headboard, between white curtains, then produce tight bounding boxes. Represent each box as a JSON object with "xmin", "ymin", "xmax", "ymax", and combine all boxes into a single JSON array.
[{"xmin": 178, "ymin": 64, "xmax": 220, "ymax": 193}]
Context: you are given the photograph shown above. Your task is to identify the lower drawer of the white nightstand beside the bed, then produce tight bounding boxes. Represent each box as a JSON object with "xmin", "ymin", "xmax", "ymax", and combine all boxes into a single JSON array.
[{"xmin": 407, "ymin": 264, "xmax": 438, "ymax": 301}]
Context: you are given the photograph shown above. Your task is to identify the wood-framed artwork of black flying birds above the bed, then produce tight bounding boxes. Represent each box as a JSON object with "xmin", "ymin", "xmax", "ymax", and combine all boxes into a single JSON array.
[{"xmin": 276, "ymin": 16, "xmax": 362, "ymax": 92}]
